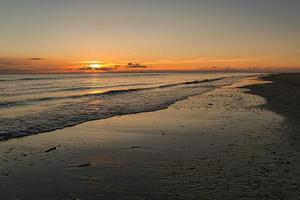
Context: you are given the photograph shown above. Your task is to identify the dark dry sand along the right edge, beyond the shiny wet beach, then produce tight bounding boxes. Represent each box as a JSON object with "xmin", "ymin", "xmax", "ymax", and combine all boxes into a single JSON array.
[{"xmin": 247, "ymin": 73, "xmax": 300, "ymax": 150}]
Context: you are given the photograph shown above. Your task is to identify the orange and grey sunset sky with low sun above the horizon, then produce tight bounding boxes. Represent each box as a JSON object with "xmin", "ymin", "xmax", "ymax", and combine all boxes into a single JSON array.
[{"xmin": 0, "ymin": 0, "xmax": 300, "ymax": 74}]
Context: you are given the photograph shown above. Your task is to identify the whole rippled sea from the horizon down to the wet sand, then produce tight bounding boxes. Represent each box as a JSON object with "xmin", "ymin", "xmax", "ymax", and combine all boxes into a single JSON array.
[{"xmin": 0, "ymin": 73, "xmax": 249, "ymax": 140}]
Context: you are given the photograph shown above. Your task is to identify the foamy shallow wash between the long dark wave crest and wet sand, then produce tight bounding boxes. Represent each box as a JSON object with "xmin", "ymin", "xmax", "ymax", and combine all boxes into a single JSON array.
[{"xmin": 0, "ymin": 86, "xmax": 214, "ymax": 141}]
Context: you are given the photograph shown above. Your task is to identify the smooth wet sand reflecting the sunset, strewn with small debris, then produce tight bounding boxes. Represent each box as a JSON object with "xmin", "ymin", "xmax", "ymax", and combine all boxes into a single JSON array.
[{"xmin": 0, "ymin": 78, "xmax": 300, "ymax": 200}]
